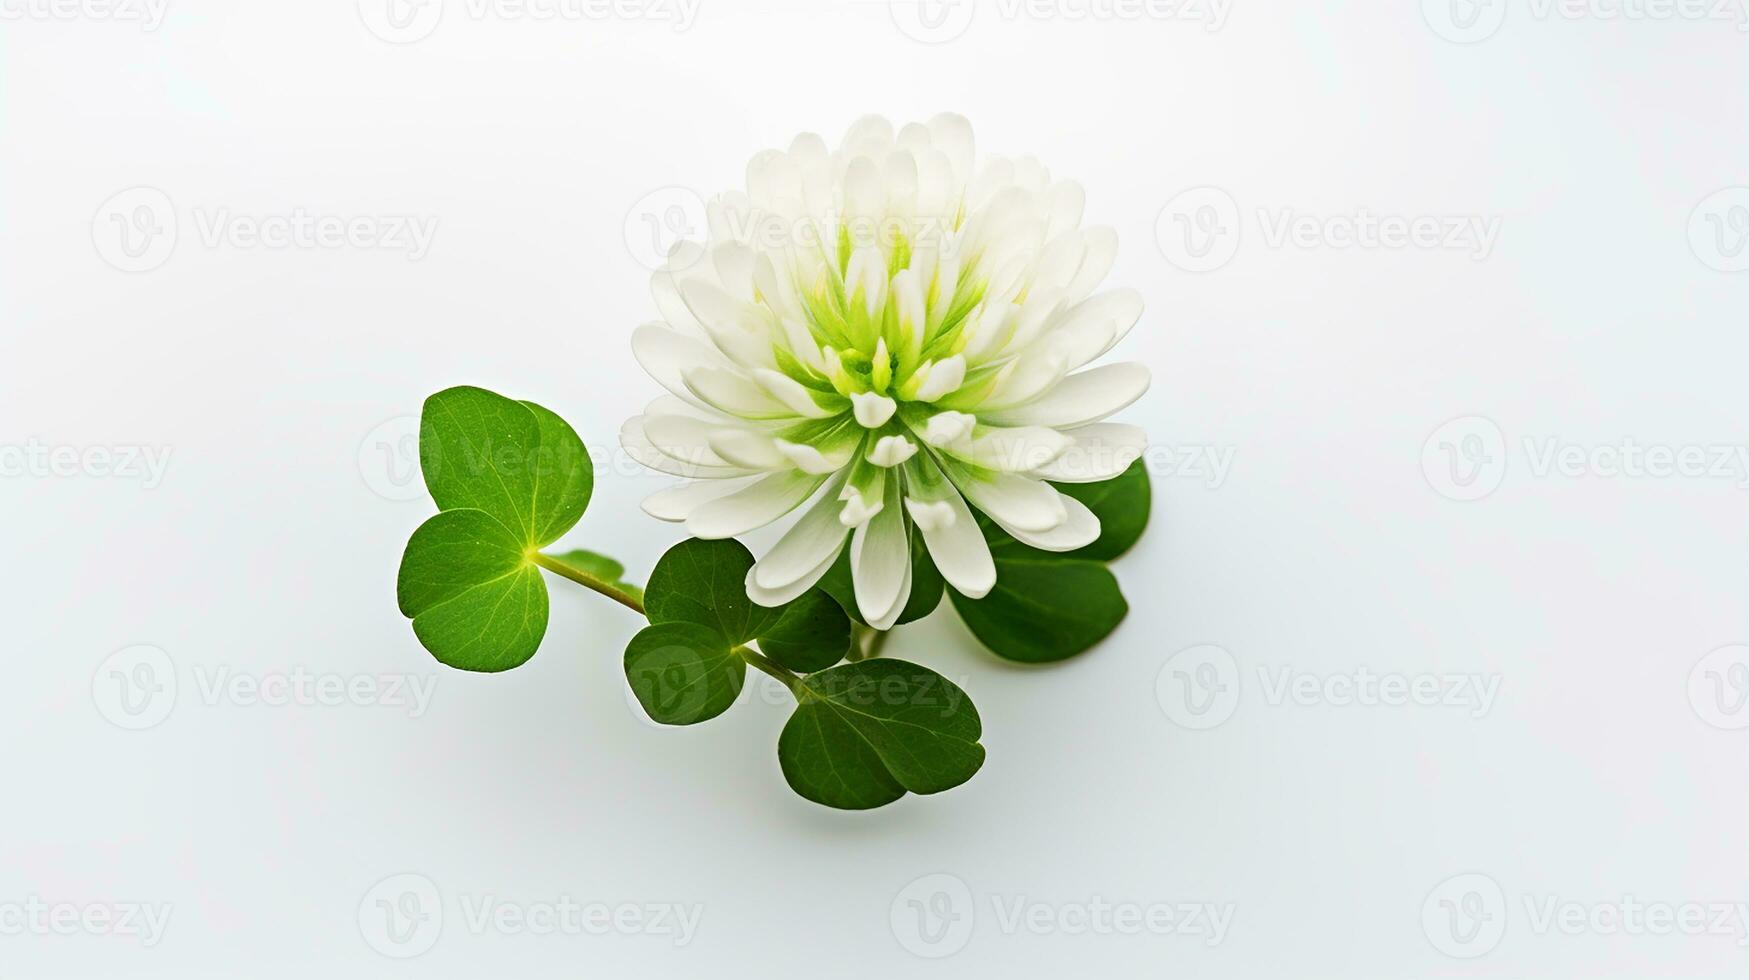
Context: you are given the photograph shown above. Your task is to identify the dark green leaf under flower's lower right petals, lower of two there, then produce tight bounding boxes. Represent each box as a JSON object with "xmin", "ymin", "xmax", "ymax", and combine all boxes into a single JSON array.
[{"xmin": 953, "ymin": 556, "xmax": 1130, "ymax": 663}]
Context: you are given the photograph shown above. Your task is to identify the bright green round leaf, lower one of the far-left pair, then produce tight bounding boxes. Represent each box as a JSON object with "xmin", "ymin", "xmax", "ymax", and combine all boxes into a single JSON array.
[{"xmin": 395, "ymin": 509, "xmax": 547, "ymax": 670}]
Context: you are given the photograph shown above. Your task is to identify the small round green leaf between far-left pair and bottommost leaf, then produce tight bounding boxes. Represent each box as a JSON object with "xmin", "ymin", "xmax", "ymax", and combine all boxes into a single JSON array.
[{"xmin": 626, "ymin": 623, "xmax": 747, "ymax": 725}]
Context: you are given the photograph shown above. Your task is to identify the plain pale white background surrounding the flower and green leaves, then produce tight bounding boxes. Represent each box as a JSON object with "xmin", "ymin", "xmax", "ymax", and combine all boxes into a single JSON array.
[{"xmin": 0, "ymin": 0, "xmax": 1749, "ymax": 978}]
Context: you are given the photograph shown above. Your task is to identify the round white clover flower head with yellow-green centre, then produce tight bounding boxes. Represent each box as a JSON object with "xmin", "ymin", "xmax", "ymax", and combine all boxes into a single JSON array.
[{"xmin": 621, "ymin": 116, "xmax": 1149, "ymax": 628}]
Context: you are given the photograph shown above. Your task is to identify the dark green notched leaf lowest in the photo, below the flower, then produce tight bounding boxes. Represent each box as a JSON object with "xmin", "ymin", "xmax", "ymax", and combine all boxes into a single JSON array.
[{"xmin": 777, "ymin": 660, "xmax": 985, "ymax": 810}]
